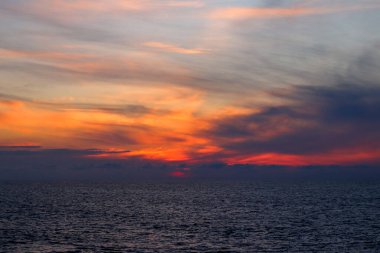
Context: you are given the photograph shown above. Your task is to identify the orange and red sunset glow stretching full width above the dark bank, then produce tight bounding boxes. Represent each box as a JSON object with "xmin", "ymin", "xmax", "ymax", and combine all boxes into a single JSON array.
[{"xmin": 0, "ymin": 96, "xmax": 380, "ymax": 166}]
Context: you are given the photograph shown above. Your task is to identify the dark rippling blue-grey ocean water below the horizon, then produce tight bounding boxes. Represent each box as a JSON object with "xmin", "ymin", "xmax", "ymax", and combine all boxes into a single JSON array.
[{"xmin": 0, "ymin": 182, "xmax": 380, "ymax": 252}]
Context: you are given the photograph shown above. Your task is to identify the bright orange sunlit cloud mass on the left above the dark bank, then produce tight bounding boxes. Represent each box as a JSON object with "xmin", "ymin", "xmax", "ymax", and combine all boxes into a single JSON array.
[{"xmin": 0, "ymin": 84, "xmax": 211, "ymax": 161}]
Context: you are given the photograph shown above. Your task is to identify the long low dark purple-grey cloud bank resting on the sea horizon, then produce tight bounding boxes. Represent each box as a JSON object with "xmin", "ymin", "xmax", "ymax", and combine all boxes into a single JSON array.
[{"xmin": 0, "ymin": 147, "xmax": 380, "ymax": 182}]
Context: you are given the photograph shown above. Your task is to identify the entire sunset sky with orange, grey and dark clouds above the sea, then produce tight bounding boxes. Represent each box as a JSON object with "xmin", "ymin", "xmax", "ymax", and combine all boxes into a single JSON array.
[{"xmin": 0, "ymin": 0, "xmax": 380, "ymax": 179}]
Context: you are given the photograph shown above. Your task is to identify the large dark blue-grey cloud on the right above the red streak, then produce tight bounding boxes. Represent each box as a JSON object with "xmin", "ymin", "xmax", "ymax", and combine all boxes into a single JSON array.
[{"xmin": 207, "ymin": 84, "xmax": 380, "ymax": 157}]
